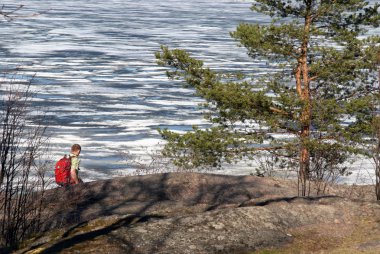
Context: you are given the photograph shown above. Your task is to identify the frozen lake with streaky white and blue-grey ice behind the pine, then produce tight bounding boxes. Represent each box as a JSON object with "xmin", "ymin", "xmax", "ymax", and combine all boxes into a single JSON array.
[{"xmin": 0, "ymin": 0, "xmax": 378, "ymax": 185}]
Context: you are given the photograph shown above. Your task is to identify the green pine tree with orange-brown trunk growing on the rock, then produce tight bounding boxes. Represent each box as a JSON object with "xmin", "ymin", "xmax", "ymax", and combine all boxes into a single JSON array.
[{"xmin": 156, "ymin": 0, "xmax": 380, "ymax": 196}]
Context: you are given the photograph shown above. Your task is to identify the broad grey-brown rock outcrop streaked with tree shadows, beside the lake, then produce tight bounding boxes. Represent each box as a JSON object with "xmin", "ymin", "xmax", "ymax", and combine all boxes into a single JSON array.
[{"xmin": 16, "ymin": 173, "xmax": 380, "ymax": 253}]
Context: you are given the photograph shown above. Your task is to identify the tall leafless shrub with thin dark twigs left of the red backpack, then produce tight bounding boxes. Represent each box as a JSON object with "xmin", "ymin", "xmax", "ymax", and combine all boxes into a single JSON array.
[{"xmin": 0, "ymin": 75, "xmax": 48, "ymax": 249}]
